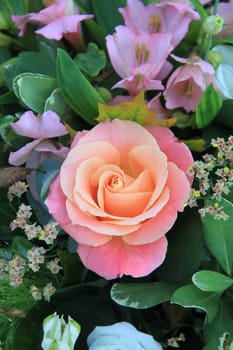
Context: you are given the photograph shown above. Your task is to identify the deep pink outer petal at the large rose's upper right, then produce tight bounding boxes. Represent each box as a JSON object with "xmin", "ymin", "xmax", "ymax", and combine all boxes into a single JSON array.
[{"xmin": 146, "ymin": 126, "xmax": 194, "ymax": 176}]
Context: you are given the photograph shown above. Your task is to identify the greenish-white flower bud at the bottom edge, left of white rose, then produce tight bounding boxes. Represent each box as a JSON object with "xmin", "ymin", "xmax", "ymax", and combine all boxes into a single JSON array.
[{"xmin": 41, "ymin": 312, "xmax": 81, "ymax": 350}]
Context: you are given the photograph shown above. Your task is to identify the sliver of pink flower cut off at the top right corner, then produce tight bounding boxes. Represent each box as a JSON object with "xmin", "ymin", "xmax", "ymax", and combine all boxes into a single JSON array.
[{"xmin": 218, "ymin": 1, "xmax": 233, "ymax": 38}]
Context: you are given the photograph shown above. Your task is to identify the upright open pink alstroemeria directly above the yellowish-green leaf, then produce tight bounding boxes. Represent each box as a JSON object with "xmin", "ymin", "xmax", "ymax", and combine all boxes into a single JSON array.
[{"xmin": 106, "ymin": 26, "xmax": 173, "ymax": 95}]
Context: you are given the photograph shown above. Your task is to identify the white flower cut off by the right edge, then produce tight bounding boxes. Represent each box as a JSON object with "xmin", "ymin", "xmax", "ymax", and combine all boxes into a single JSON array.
[{"xmin": 212, "ymin": 45, "xmax": 233, "ymax": 99}]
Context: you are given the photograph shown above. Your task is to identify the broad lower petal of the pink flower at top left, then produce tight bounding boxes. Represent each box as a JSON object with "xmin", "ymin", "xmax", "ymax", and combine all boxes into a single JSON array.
[{"xmin": 36, "ymin": 15, "xmax": 93, "ymax": 40}]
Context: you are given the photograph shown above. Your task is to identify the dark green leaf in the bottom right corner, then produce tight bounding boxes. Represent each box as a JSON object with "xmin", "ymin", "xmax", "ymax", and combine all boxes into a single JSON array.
[{"xmin": 203, "ymin": 303, "xmax": 233, "ymax": 350}]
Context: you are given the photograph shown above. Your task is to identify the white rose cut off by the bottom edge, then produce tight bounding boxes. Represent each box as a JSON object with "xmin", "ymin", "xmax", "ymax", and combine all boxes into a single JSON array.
[{"xmin": 87, "ymin": 322, "xmax": 162, "ymax": 350}]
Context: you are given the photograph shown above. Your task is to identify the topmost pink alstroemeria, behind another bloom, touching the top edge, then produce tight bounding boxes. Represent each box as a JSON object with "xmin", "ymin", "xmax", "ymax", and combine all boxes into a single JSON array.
[{"xmin": 119, "ymin": 0, "xmax": 200, "ymax": 47}]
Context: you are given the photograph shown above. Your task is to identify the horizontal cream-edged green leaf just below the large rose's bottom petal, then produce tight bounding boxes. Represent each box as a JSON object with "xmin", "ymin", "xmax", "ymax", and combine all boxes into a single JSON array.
[{"xmin": 111, "ymin": 282, "xmax": 176, "ymax": 309}]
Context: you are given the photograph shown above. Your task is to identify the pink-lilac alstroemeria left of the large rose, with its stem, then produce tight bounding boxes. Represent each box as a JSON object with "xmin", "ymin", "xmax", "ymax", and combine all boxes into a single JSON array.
[{"xmin": 8, "ymin": 111, "xmax": 69, "ymax": 198}]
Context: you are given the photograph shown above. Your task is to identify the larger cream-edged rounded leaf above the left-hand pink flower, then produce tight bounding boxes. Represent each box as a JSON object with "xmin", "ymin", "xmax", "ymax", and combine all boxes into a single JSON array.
[{"xmin": 13, "ymin": 73, "xmax": 57, "ymax": 114}]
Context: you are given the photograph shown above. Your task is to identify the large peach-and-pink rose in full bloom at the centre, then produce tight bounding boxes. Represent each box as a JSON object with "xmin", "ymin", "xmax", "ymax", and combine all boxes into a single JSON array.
[{"xmin": 46, "ymin": 119, "xmax": 193, "ymax": 279}]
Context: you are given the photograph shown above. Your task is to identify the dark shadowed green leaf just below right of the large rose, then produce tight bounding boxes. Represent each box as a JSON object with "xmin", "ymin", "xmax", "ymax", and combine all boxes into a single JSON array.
[{"xmin": 155, "ymin": 208, "xmax": 204, "ymax": 283}]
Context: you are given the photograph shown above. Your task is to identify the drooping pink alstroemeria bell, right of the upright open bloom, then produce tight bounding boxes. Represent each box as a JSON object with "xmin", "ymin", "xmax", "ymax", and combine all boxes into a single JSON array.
[{"xmin": 164, "ymin": 55, "xmax": 215, "ymax": 112}]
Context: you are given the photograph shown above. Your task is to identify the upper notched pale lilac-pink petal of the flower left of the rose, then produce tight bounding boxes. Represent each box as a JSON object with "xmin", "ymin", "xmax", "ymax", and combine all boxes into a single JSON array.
[{"xmin": 10, "ymin": 111, "xmax": 68, "ymax": 139}]
